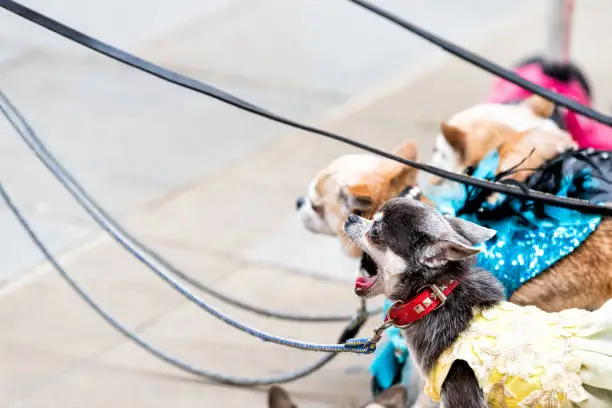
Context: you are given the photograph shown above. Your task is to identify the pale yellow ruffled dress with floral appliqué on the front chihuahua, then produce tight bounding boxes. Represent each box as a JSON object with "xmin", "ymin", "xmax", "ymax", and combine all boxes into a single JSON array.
[{"xmin": 425, "ymin": 300, "xmax": 612, "ymax": 408}]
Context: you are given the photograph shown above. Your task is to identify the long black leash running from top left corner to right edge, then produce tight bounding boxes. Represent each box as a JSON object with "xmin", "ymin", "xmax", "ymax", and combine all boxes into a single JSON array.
[{"xmin": 0, "ymin": 0, "xmax": 612, "ymax": 216}]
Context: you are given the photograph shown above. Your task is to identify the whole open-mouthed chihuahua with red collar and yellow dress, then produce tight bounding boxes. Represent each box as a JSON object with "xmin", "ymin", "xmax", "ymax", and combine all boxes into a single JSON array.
[{"xmin": 344, "ymin": 198, "xmax": 612, "ymax": 408}]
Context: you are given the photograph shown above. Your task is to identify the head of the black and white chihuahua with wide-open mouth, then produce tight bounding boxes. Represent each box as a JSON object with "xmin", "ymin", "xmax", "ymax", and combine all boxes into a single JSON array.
[{"xmin": 344, "ymin": 198, "xmax": 495, "ymax": 299}]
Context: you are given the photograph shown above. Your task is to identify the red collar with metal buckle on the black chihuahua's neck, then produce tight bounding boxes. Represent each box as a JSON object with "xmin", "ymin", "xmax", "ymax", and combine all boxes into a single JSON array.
[{"xmin": 385, "ymin": 281, "xmax": 459, "ymax": 328}]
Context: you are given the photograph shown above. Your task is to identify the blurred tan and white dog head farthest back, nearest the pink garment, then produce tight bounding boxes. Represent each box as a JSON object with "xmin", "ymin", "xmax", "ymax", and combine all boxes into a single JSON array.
[{"xmin": 419, "ymin": 95, "xmax": 576, "ymax": 195}]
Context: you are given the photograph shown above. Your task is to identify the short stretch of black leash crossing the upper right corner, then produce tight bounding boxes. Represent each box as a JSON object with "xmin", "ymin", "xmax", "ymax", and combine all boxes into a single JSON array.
[{"xmin": 349, "ymin": 0, "xmax": 612, "ymax": 126}]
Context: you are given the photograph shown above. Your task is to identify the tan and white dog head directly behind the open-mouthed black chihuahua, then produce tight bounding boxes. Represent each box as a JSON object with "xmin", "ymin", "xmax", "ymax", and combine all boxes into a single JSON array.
[{"xmin": 297, "ymin": 142, "xmax": 417, "ymax": 257}]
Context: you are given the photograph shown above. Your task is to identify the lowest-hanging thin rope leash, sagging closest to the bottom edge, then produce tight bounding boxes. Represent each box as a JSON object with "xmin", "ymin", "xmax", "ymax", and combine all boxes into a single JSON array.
[{"xmin": 0, "ymin": 182, "xmax": 368, "ymax": 386}]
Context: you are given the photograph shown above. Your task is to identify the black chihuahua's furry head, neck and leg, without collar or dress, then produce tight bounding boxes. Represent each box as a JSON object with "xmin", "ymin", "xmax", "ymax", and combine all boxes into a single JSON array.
[{"xmin": 344, "ymin": 198, "xmax": 504, "ymax": 408}]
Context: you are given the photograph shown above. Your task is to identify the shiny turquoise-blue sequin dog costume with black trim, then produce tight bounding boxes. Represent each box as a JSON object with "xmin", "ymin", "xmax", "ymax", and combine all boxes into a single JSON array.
[{"xmin": 370, "ymin": 149, "xmax": 612, "ymax": 393}]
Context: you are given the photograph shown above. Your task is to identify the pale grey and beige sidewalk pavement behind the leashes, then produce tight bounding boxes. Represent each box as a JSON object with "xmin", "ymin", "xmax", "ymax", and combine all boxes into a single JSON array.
[{"xmin": 0, "ymin": 1, "xmax": 612, "ymax": 408}]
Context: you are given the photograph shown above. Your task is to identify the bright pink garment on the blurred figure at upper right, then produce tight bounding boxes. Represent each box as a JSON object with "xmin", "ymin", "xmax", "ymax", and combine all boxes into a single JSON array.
[{"xmin": 487, "ymin": 63, "xmax": 612, "ymax": 150}]
